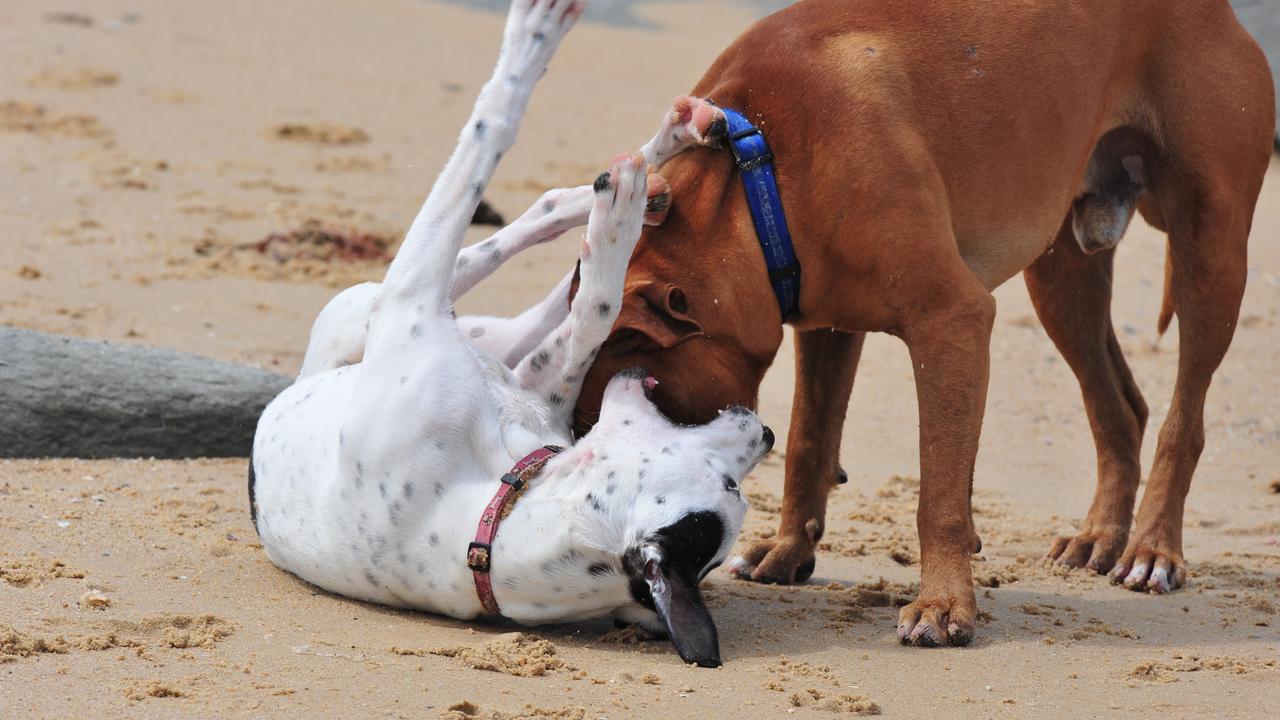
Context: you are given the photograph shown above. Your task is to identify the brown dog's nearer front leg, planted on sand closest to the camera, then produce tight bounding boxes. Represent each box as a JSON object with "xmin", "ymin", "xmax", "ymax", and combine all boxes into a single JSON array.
[{"xmin": 897, "ymin": 281, "xmax": 996, "ymax": 647}]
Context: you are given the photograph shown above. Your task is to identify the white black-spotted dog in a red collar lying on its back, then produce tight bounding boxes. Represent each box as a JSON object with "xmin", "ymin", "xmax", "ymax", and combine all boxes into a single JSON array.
[{"xmin": 250, "ymin": 0, "xmax": 773, "ymax": 666}]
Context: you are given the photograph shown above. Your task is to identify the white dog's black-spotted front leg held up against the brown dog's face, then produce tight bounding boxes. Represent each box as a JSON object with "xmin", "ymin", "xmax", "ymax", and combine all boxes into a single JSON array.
[{"xmin": 516, "ymin": 155, "xmax": 645, "ymax": 425}]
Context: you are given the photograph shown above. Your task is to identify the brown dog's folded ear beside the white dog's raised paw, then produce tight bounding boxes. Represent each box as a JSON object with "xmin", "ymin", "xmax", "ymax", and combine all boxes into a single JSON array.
[{"xmin": 605, "ymin": 281, "xmax": 703, "ymax": 355}]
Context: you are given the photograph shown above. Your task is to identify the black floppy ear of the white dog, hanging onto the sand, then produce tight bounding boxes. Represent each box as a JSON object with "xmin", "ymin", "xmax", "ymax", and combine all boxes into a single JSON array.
[{"xmin": 641, "ymin": 544, "xmax": 723, "ymax": 667}]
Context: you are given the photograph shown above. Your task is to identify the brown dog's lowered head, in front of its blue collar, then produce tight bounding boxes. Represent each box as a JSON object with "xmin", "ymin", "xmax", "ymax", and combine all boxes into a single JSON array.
[{"xmin": 575, "ymin": 150, "xmax": 782, "ymax": 433}]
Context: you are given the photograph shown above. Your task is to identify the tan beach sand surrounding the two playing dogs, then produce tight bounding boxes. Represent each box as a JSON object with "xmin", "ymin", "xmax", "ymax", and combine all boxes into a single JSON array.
[{"xmin": 0, "ymin": 0, "xmax": 1280, "ymax": 719}]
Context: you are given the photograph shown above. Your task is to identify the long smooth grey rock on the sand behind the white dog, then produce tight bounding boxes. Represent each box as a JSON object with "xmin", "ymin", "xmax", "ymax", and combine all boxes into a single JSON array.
[{"xmin": 0, "ymin": 327, "xmax": 293, "ymax": 457}]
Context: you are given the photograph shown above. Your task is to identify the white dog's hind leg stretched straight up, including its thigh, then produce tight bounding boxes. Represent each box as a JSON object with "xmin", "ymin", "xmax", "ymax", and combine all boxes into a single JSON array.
[{"xmin": 338, "ymin": 0, "xmax": 584, "ymax": 458}]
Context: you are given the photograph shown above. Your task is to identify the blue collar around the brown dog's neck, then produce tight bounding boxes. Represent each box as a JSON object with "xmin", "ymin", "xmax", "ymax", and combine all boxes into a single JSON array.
[{"xmin": 721, "ymin": 108, "xmax": 800, "ymax": 322}]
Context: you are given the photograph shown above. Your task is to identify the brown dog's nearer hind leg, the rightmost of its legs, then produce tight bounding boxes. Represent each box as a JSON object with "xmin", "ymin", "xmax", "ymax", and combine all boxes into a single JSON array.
[{"xmin": 1111, "ymin": 192, "xmax": 1256, "ymax": 593}]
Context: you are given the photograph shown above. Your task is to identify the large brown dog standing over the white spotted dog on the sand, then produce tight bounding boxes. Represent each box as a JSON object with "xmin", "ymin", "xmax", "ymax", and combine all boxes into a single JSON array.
[{"xmin": 579, "ymin": 0, "xmax": 1275, "ymax": 646}]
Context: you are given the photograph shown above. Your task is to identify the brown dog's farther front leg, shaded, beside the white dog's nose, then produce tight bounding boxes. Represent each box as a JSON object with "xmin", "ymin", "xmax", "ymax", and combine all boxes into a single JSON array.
[{"xmin": 730, "ymin": 329, "xmax": 867, "ymax": 584}]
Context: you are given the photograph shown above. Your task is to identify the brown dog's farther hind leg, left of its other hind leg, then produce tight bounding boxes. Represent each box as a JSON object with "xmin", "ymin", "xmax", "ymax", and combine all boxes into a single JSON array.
[{"xmin": 1024, "ymin": 223, "xmax": 1147, "ymax": 573}]
